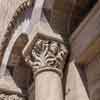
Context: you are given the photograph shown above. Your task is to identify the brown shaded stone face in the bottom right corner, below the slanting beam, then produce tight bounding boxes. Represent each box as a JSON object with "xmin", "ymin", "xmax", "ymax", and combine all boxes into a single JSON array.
[{"xmin": 85, "ymin": 55, "xmax": 100, "ymax": 100}]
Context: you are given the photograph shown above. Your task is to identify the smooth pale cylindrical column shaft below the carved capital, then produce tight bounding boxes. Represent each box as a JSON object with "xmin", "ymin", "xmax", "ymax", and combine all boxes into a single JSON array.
[{"xmin": 35, "ymin": 71, "xmax": 63, "ymax": 100}]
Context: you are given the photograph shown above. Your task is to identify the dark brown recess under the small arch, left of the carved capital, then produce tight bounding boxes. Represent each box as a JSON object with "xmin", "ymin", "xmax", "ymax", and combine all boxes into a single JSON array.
[{"xmin": 7, "ymin": 34, "xmax": 32, "ymax": 94}]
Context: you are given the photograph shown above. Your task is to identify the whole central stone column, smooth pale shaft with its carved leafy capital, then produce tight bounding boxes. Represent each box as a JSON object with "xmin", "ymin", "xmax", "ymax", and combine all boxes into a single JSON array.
[{"xmin": 24, "ymin": 35, "xmax": 68, "ymax": 100}]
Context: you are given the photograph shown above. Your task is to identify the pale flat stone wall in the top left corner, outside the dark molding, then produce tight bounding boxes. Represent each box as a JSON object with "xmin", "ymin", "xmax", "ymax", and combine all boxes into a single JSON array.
[{"xmin": 0, "ymin": 0, "xmax": 25, "ymax": 47}]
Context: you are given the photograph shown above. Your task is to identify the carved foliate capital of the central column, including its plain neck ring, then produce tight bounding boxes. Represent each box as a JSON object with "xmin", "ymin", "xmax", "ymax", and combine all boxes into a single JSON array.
[{"xmin": 22, "ymin": 35, "xmax": 68, "ymax": 76}]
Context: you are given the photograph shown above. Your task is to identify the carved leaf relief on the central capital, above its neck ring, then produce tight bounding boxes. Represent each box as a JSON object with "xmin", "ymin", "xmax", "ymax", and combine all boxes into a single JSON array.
[{"xmin": 25, "ymin": 38, "xmax": 67, "ymax": 71}]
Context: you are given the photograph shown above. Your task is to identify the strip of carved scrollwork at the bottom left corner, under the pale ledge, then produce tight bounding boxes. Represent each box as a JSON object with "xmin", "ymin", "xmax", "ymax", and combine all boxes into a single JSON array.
[{"xmin": 0, "ymin": 93, "xmax": 25, "ymax": 100}]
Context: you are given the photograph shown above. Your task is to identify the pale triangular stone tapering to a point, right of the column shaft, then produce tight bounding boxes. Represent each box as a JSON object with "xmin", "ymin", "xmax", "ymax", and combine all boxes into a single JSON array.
[{"xmin": 65, "ymin": 61, "xmax": 89, "ymax": 100}]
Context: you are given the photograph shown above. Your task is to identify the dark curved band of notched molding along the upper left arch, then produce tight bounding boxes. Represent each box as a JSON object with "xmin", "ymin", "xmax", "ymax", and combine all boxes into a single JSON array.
[{"xmin": 0, "ymin": 0, "xmax": 34, "ymax": 63}]
